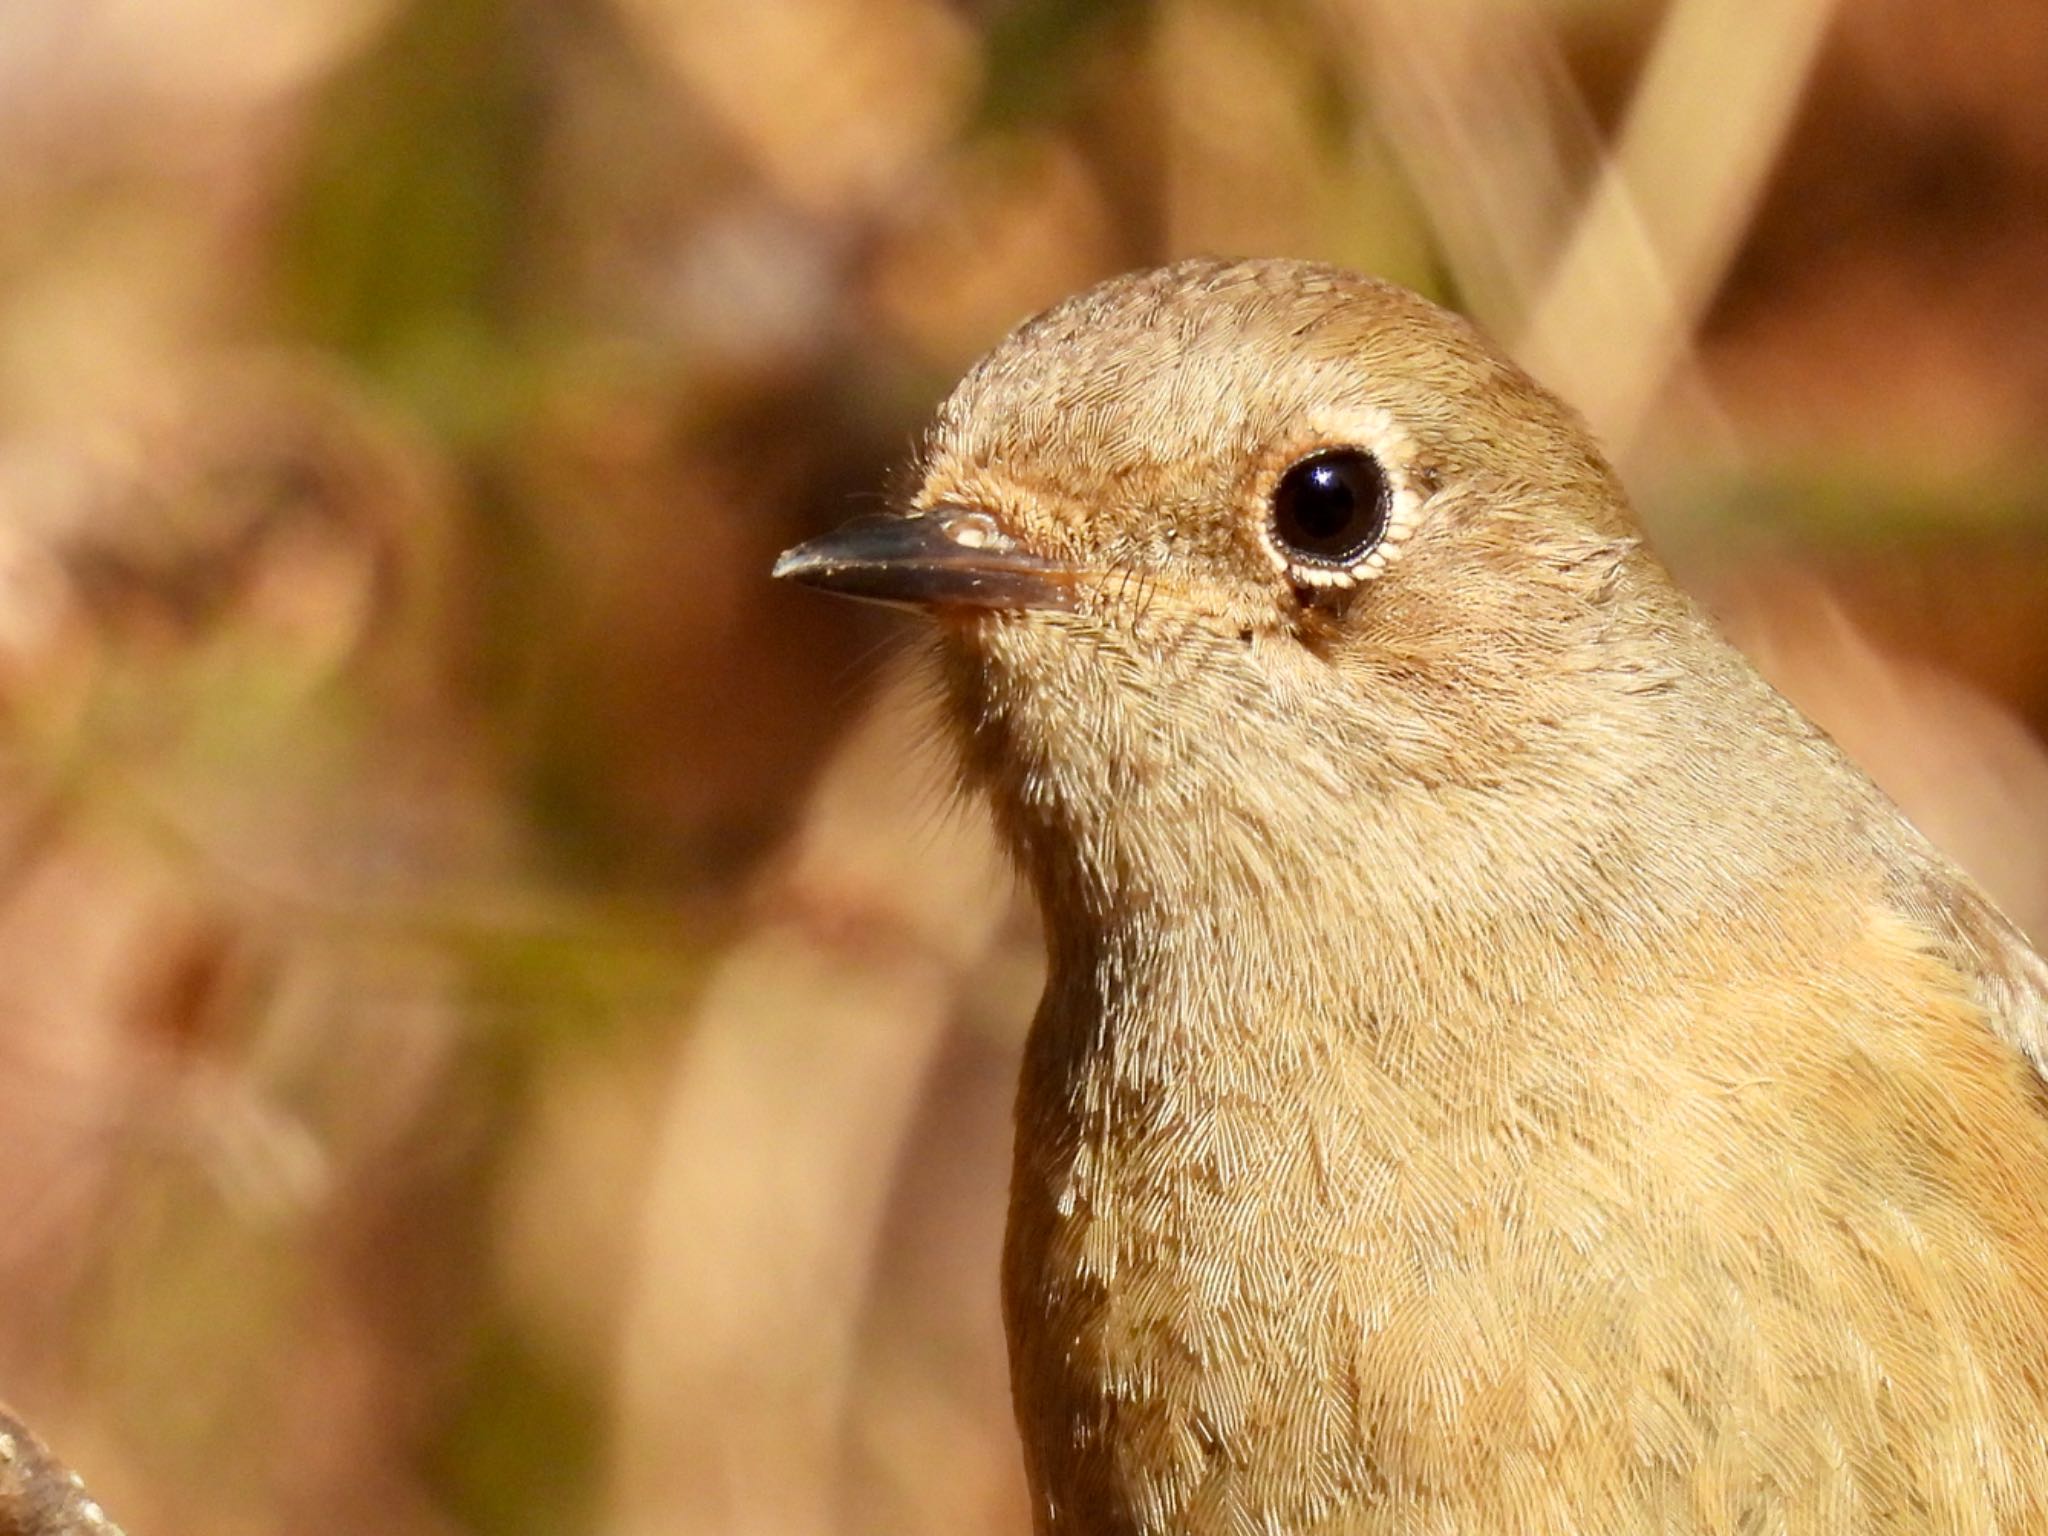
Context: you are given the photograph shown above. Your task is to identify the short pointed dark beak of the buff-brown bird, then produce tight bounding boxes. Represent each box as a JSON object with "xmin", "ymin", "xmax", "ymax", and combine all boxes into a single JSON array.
[{"xmin": 774, "ymin": 506, "xmax": 1079, "ymax": 610}]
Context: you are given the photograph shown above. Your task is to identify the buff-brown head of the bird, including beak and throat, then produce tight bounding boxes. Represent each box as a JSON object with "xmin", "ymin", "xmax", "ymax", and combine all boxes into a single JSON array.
[{"xmin": 776, "ymin": 262, "xmax": 1683, "ymax": 933}]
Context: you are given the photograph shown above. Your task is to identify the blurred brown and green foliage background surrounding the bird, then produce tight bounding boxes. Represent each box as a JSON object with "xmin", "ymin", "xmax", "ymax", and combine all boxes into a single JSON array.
[{"xmin": 0, "ymin": 0, "xmax": 2048, "ymax": 1536}]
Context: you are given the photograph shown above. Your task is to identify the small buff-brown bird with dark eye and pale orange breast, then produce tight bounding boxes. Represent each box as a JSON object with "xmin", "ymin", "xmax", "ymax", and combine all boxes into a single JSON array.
[{"xmin": 774, "ymin": 258, "xmax": 2048, "ymax": 1536}]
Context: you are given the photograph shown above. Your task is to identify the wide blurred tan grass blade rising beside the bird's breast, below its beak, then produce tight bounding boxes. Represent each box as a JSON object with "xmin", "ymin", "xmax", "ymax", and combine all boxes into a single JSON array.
[{"xmin": 612, "ymin": 659, "xmax": 1012, "ymax": 1536}]
